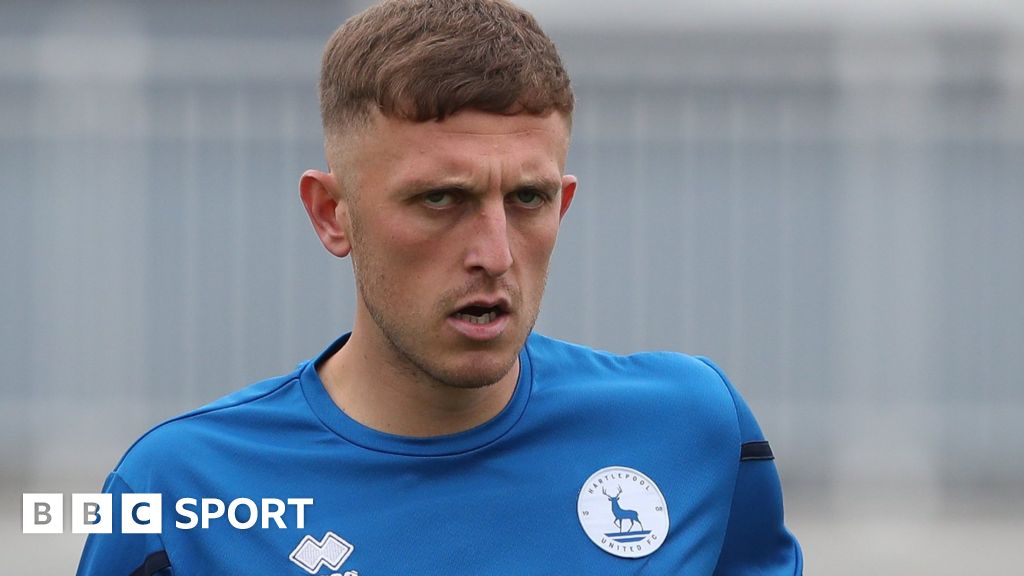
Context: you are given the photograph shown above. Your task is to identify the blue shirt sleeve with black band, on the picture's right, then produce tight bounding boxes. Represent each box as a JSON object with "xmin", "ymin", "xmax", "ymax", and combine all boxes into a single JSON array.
[{"xmin": 700, "ymin": 358, "xmax": 804, "ymax": 576}]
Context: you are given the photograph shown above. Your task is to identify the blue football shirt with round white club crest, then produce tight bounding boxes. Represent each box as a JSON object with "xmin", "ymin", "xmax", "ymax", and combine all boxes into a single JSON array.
[{"xmin": 78, "ymin": 334, "xmax": 803, "ymax": 576}]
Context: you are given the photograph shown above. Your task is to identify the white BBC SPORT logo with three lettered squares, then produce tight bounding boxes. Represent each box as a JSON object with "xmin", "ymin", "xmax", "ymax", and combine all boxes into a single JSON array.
[{"xmin": 22, "ymin": 493, "xmax": 313, "ymax": 534}]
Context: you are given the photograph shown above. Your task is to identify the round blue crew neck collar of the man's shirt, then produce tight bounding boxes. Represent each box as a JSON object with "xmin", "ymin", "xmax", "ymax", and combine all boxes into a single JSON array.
[{"xmin": 299, "ymin": 332, "xmax": 534, "ymax": 456}]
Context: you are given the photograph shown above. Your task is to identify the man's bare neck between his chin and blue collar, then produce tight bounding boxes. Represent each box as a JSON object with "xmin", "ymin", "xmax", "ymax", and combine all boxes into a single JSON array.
[{"xmin": 317, "ymin": 327, "xmax": 519, "ymax": 437}]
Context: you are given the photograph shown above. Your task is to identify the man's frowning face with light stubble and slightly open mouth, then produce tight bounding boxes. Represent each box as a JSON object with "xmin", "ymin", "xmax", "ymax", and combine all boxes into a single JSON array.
[{"xmin": 325, "ymin": 111, "xmax": 575, "ymax": 387}]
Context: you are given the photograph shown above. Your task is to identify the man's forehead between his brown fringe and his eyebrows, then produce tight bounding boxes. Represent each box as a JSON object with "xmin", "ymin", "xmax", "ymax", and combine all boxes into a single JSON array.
[{"xmin": 342, "ymin": 110, "xmax": 569, "ymax": 188}]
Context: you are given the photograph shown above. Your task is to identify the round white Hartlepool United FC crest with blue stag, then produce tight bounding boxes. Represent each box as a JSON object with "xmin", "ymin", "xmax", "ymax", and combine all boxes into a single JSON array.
[{"xmin": 577, "ymin": 466, "xmax": 669, "ymax": 558}]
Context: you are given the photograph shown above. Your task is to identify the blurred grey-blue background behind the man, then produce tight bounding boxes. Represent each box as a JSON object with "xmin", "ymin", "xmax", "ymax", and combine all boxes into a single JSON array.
[{"xmin": 0, "ymin": 0, "xmax": 1024, "ymax": 575}]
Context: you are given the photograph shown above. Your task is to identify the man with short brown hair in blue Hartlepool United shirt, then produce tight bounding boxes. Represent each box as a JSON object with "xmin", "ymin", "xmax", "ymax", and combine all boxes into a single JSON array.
[{"xmin": 79, "ymin": 0, "xmax": 802, "ymax": 576}]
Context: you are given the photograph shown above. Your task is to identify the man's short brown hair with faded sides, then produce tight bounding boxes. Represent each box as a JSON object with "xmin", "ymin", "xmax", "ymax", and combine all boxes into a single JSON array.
[{"xmin": 319, "ymin": 0, "xmax": 573, "ymax": 135}]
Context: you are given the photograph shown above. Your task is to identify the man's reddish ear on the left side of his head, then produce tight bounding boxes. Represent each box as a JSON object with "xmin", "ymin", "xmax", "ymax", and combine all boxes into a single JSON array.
[{"xmin": 299, "ymin": 170, "xmax": 352, "ymax": 258}]
